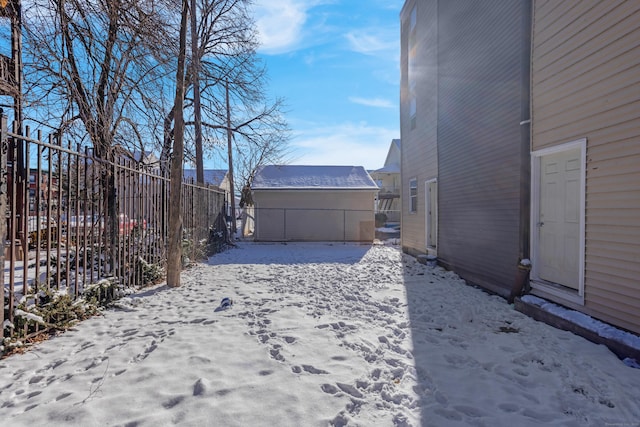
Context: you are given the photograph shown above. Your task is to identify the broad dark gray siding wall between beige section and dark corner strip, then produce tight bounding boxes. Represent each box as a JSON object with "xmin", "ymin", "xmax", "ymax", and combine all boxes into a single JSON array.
[{"xmin": 436, "ymin": 0, "xmax": 531, "ymax": 296}]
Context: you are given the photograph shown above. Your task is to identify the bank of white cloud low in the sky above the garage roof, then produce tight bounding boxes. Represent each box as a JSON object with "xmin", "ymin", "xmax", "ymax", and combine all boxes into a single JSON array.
[{"xmin": 291, "ymin": 122, "xmax": 400, "ymax": 170}]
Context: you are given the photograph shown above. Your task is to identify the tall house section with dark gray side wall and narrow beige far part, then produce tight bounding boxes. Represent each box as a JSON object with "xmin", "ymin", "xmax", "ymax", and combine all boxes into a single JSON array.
[{"xmin": 400, "ymin": 0, "xmax": 531, "ymax": 296}]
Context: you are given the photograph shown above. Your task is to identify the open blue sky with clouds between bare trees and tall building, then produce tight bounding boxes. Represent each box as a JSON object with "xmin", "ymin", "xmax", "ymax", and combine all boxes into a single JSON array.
[{"xmin": 248, "ymin": 0, "xmax": 404, "ymax": 169}]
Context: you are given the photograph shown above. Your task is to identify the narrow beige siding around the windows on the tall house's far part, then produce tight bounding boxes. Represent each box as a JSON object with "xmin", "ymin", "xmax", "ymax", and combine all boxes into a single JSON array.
[{"xmin": 400, "ymin": 0, "xmax": 438, "ymax": 254}]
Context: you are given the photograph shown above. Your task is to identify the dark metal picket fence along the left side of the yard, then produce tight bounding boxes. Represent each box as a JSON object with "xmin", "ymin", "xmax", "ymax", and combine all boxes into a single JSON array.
[{"xmin": 0, "ymin": 118, "xmax": 227, "ymax": 348}]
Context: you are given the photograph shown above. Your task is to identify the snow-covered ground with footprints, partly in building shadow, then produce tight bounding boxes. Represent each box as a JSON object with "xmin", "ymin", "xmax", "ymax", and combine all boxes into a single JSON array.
[{"xmin": 0, "ymin": 243, "xmax": 640, "ymax": 427}]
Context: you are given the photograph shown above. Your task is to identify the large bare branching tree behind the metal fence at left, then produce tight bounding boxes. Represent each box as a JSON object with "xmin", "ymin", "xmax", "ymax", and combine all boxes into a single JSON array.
[{"xmin": 24, "ymin": 0, "xmax": 174, "ymax": 258}]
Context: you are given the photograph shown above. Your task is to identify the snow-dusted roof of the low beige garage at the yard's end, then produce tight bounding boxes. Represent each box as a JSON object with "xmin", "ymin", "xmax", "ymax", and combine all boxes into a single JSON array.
[{"xmin": 251, "ymin": 165, "xmax": 378, "ymax": 190}]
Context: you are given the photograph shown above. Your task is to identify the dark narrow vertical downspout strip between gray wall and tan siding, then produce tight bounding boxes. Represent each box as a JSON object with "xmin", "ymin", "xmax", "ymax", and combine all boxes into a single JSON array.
[{"xmin": 508, "ymin": 0, "xmax": 535, "ymax": 303}]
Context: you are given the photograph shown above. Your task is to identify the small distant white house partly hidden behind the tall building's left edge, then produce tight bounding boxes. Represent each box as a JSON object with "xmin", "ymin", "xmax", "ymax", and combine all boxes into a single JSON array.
[{"xmin": 369, "ymin": 139, "xmax": 402, "ymax": 222}]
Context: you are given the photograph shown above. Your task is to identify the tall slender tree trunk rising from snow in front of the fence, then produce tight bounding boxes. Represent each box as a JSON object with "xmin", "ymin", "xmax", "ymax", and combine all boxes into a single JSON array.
[{"xmin": 167, "ymin": 0, "xmax": 189, "ymax": 287}]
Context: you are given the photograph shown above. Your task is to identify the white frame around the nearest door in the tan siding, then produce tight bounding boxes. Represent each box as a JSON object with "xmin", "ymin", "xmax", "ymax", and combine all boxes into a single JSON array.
[{"xmin": 530, "ymin": 138, "xmax": 587, "ymax": 305}]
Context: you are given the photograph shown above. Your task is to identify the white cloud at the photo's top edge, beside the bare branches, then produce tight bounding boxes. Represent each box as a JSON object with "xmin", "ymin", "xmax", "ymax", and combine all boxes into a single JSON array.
[{"xmin": 254, "ymin": 0, "xmax": 314, "ymax": 54}]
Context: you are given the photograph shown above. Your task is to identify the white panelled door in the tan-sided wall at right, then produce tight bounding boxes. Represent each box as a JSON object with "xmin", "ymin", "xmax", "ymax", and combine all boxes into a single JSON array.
[{"xmin": 537, "ymin": 149, "xmax": 582, "ymax": 289}]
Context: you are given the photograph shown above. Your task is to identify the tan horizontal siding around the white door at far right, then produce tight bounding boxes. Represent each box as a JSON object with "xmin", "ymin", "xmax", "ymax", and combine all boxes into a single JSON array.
[{"xmin": 532, "ymin": 0, "xmax": 640, "ymax": 333}]
